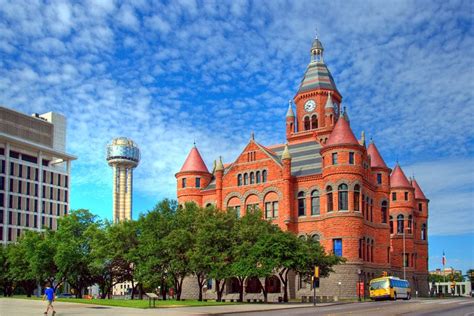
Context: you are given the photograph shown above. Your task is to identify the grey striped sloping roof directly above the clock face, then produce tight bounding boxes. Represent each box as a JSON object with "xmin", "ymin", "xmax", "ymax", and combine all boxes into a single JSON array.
[{"xmin": 298, "ymin": 61, "xmax": 337, "ymax": 93}]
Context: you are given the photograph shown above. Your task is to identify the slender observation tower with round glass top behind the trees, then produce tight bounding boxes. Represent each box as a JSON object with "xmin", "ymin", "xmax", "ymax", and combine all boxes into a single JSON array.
[{"xmin": 107, "ymin": 137, "xmax": 140, "ymax": 223}]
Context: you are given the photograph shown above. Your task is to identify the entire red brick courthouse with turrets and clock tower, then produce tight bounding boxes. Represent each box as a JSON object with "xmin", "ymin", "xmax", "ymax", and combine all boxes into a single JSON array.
[{"xmin": 176, "ymin": 39, "xmax": 429, "ymax": 298}]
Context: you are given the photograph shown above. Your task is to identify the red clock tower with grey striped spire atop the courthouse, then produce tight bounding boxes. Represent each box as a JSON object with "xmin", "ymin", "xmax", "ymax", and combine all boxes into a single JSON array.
[{"xmin": 287, "ymin": 38, "xmax": 342, "ymax": 143}]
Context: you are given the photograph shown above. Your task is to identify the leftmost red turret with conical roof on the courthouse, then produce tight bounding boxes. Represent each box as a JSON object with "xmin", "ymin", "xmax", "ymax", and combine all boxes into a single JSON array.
[{"xmin": 175, "ymin": 145, "xmax": 211, "ymax": 205}]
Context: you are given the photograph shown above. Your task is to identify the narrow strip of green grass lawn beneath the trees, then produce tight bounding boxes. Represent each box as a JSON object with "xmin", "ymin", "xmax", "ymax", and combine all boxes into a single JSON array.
[{"xmin": 10, "ymin": 295, "xmax": 239, "ymax": 308}]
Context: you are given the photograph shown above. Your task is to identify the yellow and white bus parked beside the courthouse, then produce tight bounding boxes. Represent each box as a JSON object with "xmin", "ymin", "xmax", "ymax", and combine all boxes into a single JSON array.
[{"xmin": 370, "ymin": 277, "xmax": 411, "ymax": 300}]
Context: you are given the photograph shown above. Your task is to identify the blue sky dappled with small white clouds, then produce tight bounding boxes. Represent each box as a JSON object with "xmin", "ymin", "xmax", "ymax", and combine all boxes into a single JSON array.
[{"xmin": 0, "ymin": 0, "xmax": 474, "ymax": 270}]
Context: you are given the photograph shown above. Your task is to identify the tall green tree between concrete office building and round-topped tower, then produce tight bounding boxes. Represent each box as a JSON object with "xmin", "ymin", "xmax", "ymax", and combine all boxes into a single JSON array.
[{"xmin": 54, "ymin": 209, "xmax": 98, "ymax": 298}]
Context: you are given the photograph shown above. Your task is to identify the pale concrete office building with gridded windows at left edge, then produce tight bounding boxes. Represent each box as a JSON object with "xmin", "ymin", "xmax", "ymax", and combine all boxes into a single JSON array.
[{"xmin": 0, "ymin": 107, "xmax": 76, "ymax": 244}]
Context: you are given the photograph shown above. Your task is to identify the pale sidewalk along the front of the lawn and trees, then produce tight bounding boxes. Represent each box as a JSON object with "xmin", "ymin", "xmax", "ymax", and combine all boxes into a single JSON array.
[{"xmin": 0, "ymin": 298, "xmax": 344, "ymax": 316}]
